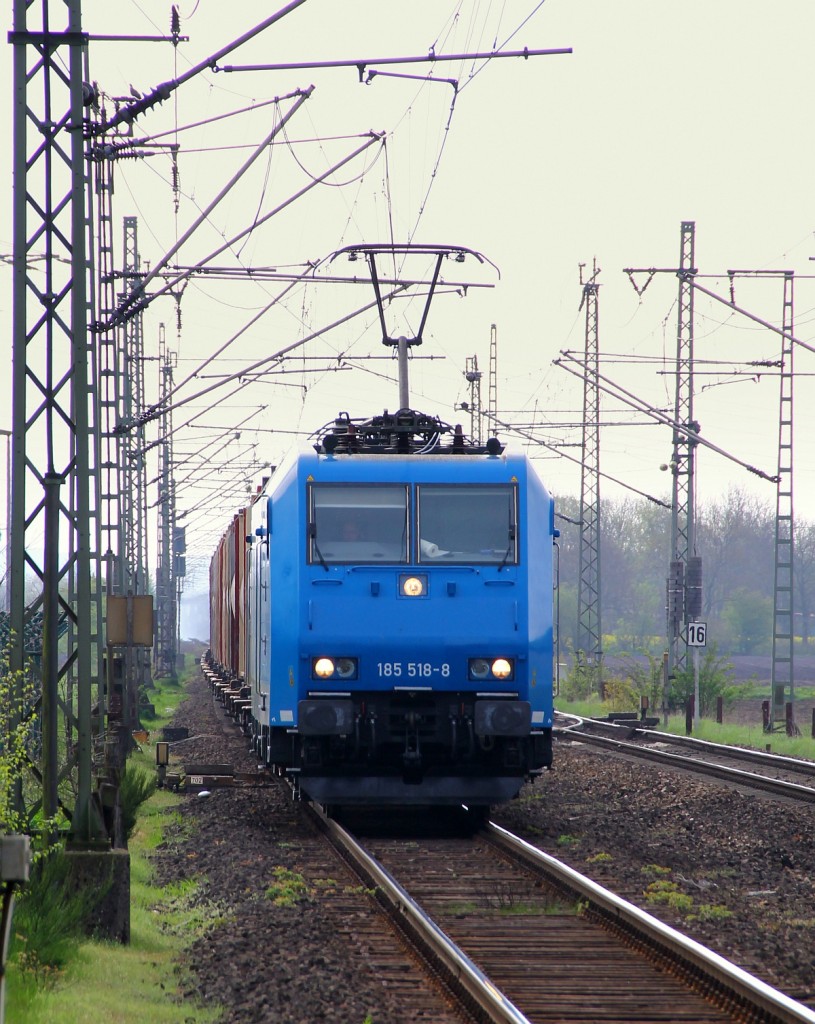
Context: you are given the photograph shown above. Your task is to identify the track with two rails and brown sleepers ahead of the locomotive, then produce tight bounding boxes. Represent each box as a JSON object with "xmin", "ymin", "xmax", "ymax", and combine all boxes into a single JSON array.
[{"xmin": 307, "ymin": 802, "xmax": 815, "ymax": 1024}]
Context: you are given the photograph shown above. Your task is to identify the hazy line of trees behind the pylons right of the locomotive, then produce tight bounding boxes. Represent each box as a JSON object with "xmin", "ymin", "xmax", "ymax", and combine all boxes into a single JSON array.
[{"xmin": 556, "ymin": 488, "xmax": 815, "ymax": 654}]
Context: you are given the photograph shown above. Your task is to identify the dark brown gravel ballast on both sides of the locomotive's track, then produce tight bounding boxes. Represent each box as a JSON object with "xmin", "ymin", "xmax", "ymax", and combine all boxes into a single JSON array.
[{"xmin": 154, "ymin": 678, "xmax": 815, "ymax": 1024}]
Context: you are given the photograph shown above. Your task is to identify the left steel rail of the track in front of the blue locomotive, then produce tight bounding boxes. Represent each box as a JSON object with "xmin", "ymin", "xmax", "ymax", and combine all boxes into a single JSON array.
[{"xmin": 311, "ymin": 806, "xmax": 536, "ymax": 1024}]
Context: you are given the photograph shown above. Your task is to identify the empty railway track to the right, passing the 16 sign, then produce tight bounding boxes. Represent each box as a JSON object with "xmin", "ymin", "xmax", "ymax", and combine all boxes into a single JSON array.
[{"xmin": 555, "ymin": 719, "xmax": 815, "ymax": 804}]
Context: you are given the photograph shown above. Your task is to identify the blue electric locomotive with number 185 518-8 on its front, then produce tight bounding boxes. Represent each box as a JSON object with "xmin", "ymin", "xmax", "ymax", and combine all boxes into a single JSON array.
[{"xmin": 222, "ymin": 409, "xmax": 555, "ymax": 807}]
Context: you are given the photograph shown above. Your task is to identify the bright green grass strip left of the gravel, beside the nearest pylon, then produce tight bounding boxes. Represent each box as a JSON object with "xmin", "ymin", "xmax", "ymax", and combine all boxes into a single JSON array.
[{"xmin": 5, "ymin": 663, "xmax": 220, "ymax": 1024}]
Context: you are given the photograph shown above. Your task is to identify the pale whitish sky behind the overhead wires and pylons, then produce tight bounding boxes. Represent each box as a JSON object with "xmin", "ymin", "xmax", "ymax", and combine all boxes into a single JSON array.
[{"xmin": 0, "ymin": 0, "xmax": 815, "ymax": 598}]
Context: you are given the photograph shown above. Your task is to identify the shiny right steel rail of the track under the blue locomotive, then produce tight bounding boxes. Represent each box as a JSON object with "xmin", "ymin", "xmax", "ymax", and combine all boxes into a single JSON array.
[{"xmin": 485, "ymin": 822, "xmax": 815, "ymax": 1024}]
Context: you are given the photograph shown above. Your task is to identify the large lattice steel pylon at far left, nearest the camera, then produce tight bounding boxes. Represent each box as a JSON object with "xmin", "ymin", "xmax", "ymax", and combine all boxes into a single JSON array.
[{"xmin": 10, "ymin": 0, "xmax": 105, "ymax": 843}]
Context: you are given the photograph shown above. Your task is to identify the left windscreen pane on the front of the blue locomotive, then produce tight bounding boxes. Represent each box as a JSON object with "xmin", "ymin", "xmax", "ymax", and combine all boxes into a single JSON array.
[{"xmin": 308, "ymin": 483, "xmax": 408, "ymax": 565}]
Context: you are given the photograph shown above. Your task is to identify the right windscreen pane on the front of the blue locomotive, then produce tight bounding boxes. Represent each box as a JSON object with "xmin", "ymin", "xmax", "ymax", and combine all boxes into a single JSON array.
[{"xmin": 417, "ymin": 484, "xmax": 518, "ymax": 565}]
